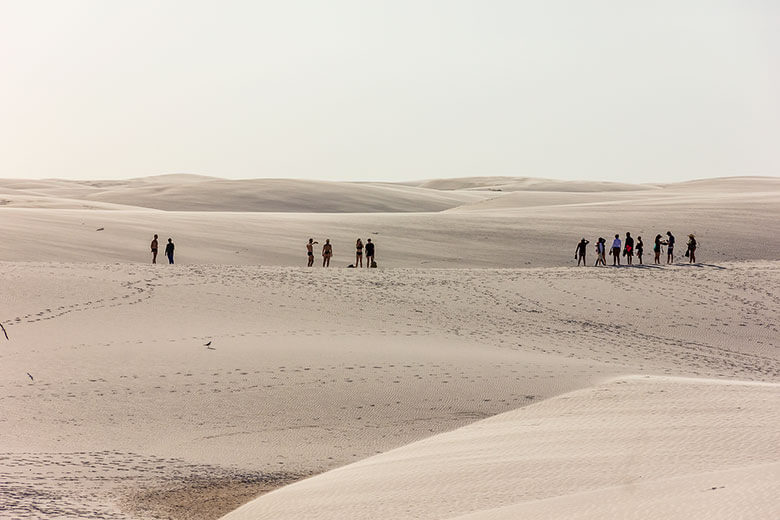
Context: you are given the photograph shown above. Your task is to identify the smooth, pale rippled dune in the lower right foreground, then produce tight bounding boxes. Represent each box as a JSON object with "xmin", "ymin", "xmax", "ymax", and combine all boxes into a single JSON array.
[{"xmin": 219, "ymin": 377, "xmax": 780, "ymax": 520}]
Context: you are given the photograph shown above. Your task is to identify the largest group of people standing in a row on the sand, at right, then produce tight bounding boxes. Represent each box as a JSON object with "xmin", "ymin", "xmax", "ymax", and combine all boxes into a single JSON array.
[{"xmin": 574, "ymin": 231, "xmax": 697, "ymax": 266}]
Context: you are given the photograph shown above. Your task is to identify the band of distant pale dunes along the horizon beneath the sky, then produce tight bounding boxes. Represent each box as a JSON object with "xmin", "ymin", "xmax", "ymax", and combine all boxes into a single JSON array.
[{"xmin": 0, "ymin": 174, "xmax": 780, "ymax": 213}]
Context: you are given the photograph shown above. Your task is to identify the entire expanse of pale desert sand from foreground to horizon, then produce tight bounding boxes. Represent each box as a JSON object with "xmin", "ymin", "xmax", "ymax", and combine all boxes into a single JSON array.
[{"xmin": 0, "ymin": 175, "xmax": 780, "ymax": 520}]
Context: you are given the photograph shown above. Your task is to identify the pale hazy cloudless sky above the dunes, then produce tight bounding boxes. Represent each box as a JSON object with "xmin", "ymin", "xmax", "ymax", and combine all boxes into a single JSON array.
[{"xmin": 0, "ymin": 0, "xmax": 780, "ymax": 181}]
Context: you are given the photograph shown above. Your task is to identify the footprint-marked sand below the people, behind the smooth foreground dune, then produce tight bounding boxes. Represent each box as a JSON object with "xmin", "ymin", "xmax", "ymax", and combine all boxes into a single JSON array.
[{"xmin": 0, "ymin": 262, "xmax": 780, "ymax": 519}]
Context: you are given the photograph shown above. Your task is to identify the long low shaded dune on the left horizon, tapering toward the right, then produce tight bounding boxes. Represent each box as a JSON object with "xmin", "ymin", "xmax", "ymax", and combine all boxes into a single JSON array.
[{"xmin": 0, "ymin": 175, "xmax": 485, "ymax": 213}]
